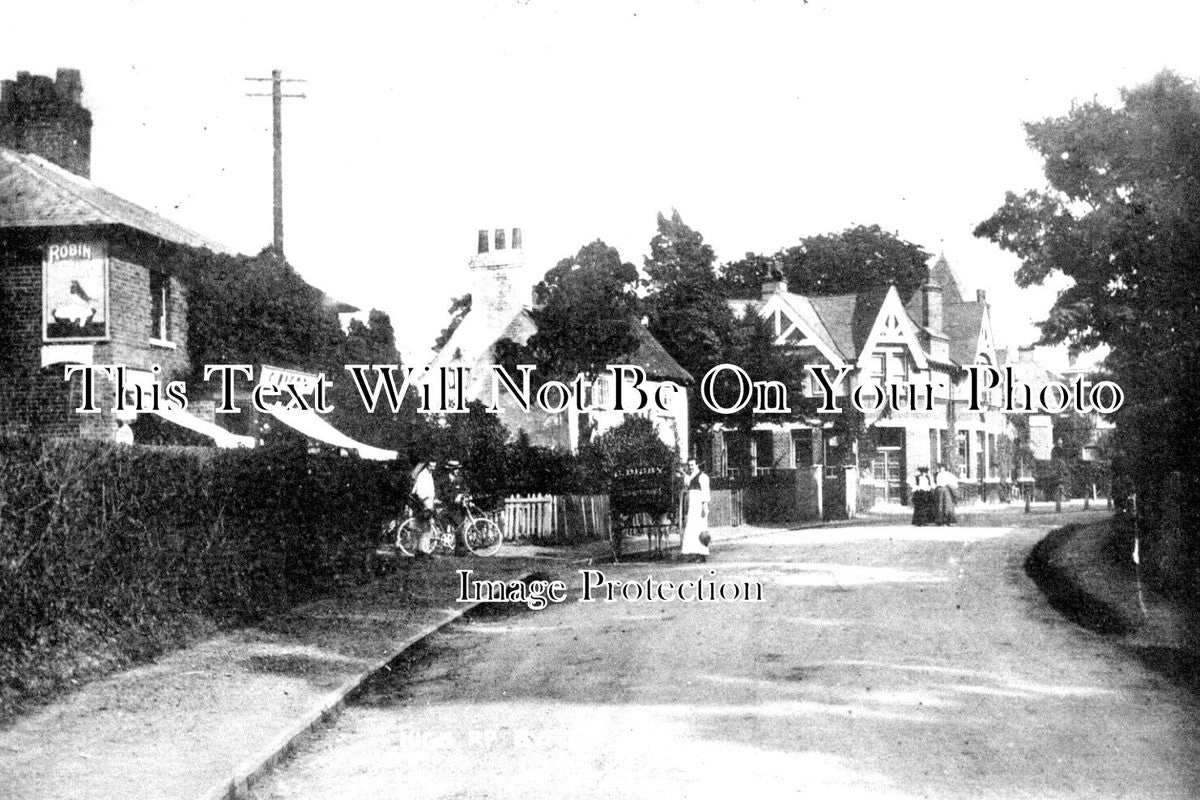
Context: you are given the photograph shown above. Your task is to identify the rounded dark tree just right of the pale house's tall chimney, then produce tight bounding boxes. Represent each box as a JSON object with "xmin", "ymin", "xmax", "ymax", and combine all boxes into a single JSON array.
[{"xmin": 497, "ymin": 239, "xmax": 641, "ymax": 380}]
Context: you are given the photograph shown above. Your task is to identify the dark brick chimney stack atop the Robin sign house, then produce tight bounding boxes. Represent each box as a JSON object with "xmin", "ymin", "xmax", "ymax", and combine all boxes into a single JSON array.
[{"xmin": 0, "ymin": 70, "xmax": 91, "ymax": 178}]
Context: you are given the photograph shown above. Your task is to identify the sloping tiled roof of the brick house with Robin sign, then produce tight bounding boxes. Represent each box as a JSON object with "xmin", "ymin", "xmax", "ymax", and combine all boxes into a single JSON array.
[{"xmin": 0, "ymin": 148, "xmax": 232, "ymax": 253}]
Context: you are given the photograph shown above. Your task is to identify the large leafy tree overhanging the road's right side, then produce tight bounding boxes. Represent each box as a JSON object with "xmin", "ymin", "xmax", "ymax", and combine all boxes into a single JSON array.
[{"xmin": 976, "ymin": 72, "xmax": 1200, "ymax": 544}]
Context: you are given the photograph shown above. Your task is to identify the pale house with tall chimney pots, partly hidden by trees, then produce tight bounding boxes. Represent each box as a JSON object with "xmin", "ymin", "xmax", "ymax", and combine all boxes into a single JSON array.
[{"xmin": 425, "ymin": 228, "xmax": 692, "ymax": 457}]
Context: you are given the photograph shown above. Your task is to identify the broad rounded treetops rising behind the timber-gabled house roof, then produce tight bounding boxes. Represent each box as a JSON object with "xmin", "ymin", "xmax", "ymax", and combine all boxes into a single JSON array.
[{"xmin": 722, "ymin": 225, "xmax": 930, "ymax": 302}]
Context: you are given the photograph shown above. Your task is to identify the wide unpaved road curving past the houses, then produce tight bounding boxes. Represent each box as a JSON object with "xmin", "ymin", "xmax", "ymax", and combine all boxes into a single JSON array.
[{"xmin": 253, "ymin": 525, "xmax": 1200, "ymax": 800}]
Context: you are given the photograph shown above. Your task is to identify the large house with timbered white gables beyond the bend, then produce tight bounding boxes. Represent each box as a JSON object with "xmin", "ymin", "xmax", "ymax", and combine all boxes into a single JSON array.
[{"xmin": 713, "ymin": 257, "xmax": 1012, "ymax": 516}]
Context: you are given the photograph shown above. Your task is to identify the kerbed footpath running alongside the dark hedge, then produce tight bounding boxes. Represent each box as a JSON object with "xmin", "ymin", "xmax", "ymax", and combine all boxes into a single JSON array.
[{"xmin": 0, "ymin": 543, "xmax": 606, "ymax": 800}]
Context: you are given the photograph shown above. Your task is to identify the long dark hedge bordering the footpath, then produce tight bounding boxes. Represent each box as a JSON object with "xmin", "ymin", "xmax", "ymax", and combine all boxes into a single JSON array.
[{"xmin": 0, "ymin": 438, "xmax": 407, "ymax": 714}]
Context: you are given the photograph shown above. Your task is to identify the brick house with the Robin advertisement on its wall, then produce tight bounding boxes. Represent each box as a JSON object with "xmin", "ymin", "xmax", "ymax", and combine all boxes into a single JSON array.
[{"xmin": 0, "ymin": 70, "xmax": 238, "ymax": 441}]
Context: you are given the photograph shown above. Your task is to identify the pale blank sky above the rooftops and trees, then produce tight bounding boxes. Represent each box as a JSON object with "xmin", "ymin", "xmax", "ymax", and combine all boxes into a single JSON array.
[{"xmin": 0, "ymin": 0, "xmax": 1200, "ymax": 361}]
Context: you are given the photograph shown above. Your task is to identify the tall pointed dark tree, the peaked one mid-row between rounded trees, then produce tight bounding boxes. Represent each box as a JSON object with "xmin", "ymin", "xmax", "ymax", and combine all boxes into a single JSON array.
[{"xmin": 646, "ymin": 210, "xmax": 733, "ymax": 395}]
